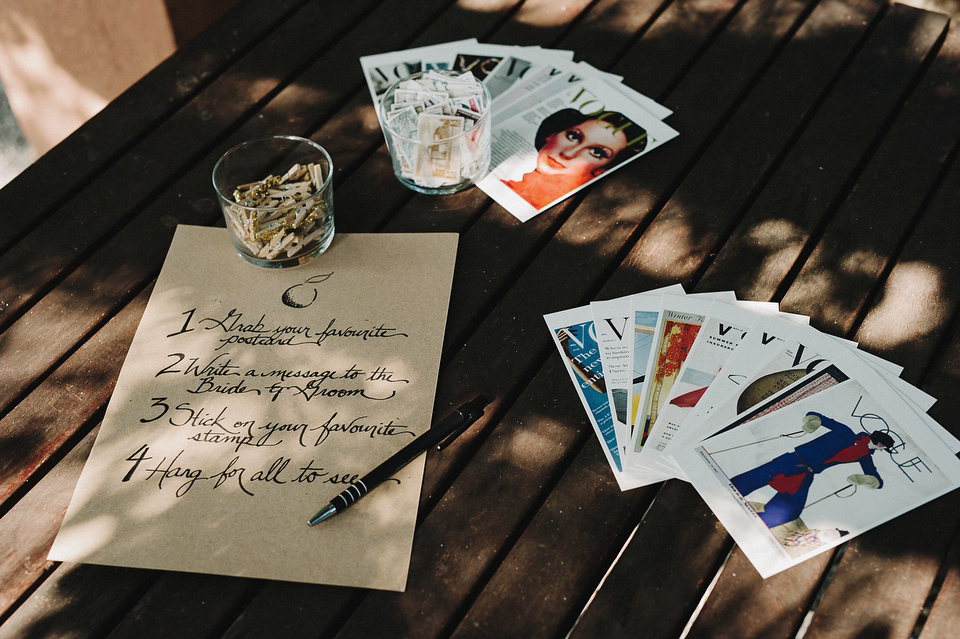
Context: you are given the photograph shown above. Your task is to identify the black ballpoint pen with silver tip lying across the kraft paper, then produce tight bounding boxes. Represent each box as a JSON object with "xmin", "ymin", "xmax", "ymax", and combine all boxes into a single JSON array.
[{"xmin": 307, "ymin": 396, "xmax": 490, "ymax": 526}]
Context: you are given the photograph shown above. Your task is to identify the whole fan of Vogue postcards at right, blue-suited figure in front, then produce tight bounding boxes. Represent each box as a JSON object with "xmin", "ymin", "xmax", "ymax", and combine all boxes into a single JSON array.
[{"xmin": 544, "ymin": 285, "xmax": 960, "ymax": 578}]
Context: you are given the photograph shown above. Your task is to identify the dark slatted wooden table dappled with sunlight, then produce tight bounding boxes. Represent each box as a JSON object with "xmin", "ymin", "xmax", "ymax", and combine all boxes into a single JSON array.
[{"xmin": 0, "ymin": 0, "xmax": 960, "ymax": 639}]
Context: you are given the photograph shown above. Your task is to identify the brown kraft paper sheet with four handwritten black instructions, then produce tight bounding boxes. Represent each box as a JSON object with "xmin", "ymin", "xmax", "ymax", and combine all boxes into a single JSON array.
[{"xmin": 49, "ymin": 226, "xmax": 457, "ymax": 590}]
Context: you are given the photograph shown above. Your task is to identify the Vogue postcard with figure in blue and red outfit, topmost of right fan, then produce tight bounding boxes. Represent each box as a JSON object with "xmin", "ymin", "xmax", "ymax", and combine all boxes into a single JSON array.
[{"xmin": 675, "ymin": 375, "xmax": 960, "ymax": 578}]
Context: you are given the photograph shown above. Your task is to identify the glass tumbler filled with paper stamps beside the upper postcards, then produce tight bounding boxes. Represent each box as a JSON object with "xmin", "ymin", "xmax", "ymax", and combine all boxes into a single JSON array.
[{"xmin": 381, "ymin": 70, "xmax": 490, "ymax": 188}]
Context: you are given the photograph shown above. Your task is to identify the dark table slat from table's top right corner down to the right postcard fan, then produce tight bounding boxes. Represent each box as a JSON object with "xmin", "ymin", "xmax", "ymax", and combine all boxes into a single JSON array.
[{"xmin": 702, "ymin": 5, "xmax": 947, "ymax": 299}]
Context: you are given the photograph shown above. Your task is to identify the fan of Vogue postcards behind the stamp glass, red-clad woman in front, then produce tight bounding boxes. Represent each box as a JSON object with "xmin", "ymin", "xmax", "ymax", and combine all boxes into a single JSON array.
[{"xmin": 360, "ymin": 39, "xmax": 677, "ymax": 221}]
